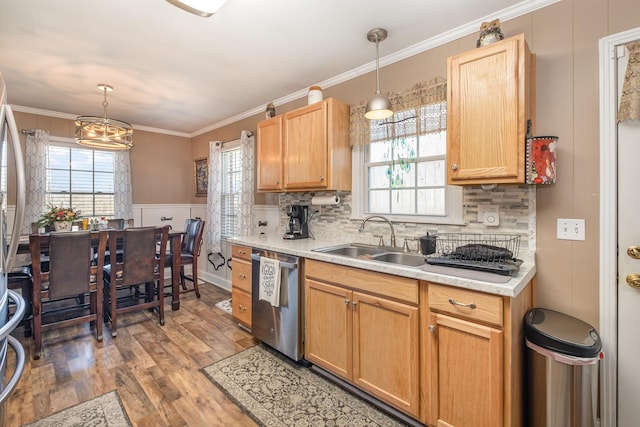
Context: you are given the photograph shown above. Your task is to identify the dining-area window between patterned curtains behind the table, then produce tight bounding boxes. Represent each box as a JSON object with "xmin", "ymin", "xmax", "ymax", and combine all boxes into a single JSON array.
[{"xmin": 45, "ymin": 144, "xmax": 115, "ymax": 217}]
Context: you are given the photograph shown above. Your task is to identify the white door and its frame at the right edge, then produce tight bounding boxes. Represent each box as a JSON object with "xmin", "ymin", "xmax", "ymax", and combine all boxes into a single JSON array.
[{"xmin": 600, "ymin": 27, "xmax": 640, "ymax": 427}]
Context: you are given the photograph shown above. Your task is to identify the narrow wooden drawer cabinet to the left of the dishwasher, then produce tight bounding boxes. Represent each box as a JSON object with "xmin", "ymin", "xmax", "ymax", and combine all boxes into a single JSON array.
[{"xmin": 231, "ymin": 245, "xmax": 251, "ymax": 329}]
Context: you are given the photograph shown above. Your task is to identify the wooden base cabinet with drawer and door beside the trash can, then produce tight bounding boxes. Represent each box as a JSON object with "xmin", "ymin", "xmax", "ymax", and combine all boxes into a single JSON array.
[{"xmin": 421, "ymin": 282, "xmax": 532, "ymax": 427}]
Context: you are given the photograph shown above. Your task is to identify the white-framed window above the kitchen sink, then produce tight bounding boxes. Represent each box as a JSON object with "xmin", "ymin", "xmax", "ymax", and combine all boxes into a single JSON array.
[{"xmin": 353, "ymin": 102, "xmax": 462, "ymax": 224}]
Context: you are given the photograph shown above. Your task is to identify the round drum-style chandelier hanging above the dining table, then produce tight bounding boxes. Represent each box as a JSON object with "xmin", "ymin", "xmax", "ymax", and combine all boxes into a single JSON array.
[{"xmin": 75, "ymin": 83, "xmax": 133, "ymax": 150}]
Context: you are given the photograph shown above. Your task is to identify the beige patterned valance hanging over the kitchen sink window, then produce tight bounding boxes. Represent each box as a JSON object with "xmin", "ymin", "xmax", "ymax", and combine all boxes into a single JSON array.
[{"xmin": 349, "ymin": 77, "xmax": 447, "ymax": 146}]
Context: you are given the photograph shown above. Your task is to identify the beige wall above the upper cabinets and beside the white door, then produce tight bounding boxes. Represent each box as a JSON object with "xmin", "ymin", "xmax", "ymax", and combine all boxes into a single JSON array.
[{"xmin": 193, "ymin": 0, "xmax": 640, "ymax": 327}]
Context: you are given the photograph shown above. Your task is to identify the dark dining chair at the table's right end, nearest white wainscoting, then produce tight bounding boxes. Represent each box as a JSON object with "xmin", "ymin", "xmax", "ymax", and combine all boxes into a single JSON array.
[{"xmin": 165, "ymin": 218, "xmax": 204, "ymax": 298}]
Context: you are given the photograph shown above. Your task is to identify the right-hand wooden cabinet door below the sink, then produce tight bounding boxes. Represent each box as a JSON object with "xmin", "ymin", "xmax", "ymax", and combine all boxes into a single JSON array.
[{"xmin": 352, "ymin": 292, "xmax": 420, "ymax": 416}]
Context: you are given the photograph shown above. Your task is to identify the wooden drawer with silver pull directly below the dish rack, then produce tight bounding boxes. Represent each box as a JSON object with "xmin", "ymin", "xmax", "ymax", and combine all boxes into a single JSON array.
[{"xmin": 428, "ymin": 283, "xmax": 503, "ymax": 326}]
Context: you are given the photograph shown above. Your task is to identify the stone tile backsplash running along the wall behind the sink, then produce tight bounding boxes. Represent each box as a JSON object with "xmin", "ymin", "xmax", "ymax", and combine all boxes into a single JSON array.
[{"xmin": 279, "ymin": 185, "xmax": 535, "ymax": 250}]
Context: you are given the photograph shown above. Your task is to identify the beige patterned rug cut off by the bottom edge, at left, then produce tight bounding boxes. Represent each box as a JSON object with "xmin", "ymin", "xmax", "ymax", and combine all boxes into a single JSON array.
[{"xmin": 27, "ymin": 391, "xmax": 131, "ymax": 427}]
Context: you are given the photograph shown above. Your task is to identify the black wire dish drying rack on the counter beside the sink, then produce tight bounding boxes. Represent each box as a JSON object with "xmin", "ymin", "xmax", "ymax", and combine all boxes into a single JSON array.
[{"xmin": 426, "ymin": 233, "xmax": 522, "ymax": 276}]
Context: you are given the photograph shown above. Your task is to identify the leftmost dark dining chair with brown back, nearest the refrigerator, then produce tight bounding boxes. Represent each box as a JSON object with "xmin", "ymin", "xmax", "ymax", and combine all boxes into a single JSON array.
[{"xmin": 29, "ymin": 231, "xmax": 107, "ymax": 359}]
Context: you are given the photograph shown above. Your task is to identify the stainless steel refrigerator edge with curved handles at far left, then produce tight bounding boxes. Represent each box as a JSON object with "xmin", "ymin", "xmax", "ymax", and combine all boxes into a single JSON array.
[{"xmin": 0, "ymin": 71, "xmax": 26, "ymax": 426}]
